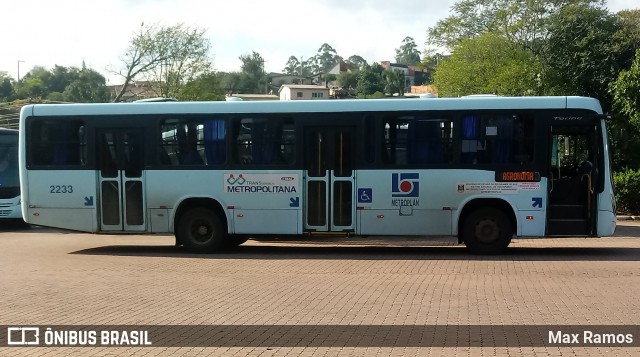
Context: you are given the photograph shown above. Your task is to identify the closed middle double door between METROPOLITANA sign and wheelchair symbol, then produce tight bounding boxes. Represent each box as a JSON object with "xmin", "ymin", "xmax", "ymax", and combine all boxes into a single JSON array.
[{"xmin": 304, "ymin": 126, "xmax": 355, "ymax": 233}]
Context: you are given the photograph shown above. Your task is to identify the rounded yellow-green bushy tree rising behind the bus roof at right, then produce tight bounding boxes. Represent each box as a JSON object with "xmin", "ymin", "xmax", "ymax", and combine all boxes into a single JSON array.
[{"xmin": 434, "ymin": 33, "xmax": 541, "ymax": 97}]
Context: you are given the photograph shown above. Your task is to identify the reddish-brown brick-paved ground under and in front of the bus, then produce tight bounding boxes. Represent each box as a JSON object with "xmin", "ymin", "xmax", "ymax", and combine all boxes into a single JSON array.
[{"xmin": 0, "ymin": 222, "xmax": 640, "ymax": 356}]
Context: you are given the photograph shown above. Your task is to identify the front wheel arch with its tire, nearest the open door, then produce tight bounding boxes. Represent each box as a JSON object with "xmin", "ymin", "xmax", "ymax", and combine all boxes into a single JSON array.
[{"xmin": 458, "ymin": 199, "xmax": 517, "ymax": 254}]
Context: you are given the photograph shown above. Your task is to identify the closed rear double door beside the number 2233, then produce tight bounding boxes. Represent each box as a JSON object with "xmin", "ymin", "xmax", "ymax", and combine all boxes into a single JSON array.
[{"xmin": 96, "ymin": 129, "xmax": 146, "ymax": 231}]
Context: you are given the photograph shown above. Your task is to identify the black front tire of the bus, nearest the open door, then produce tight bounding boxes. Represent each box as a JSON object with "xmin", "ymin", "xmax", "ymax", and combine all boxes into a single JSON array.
[{"xmin": 462, "ymin": 207, "xmax": 514, "ymax": 254}]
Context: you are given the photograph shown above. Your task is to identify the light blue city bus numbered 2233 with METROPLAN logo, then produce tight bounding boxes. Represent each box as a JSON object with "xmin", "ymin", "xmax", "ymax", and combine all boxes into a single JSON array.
[{"xmin": 20, "ymin": 96, "xmax": 616, "ymax": 254}]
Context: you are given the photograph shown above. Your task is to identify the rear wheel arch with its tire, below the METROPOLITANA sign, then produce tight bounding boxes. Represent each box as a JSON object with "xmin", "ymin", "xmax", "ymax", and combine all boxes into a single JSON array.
[{"xmin": 173, "ymin": 198, "xmax": 228, "ymax": 253}]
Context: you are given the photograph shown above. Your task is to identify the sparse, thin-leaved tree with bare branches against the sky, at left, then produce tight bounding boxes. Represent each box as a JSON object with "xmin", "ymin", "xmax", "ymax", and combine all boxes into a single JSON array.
[{"xmin": 113, "ymin": 24, "xmax": 211, "ymax": 102}]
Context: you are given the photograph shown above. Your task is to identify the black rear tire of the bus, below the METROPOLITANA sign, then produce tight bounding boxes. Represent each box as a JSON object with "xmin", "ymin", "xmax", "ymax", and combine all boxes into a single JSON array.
[{"xmin": 176, "ymin": 207, "xmax": 227, "ymax": 253}]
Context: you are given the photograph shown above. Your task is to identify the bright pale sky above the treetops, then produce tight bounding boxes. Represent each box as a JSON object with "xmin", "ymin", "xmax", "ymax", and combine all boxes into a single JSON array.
[{"xmin": 0, "ymin": 0, "xmax": 640, "ymax": 84}]
